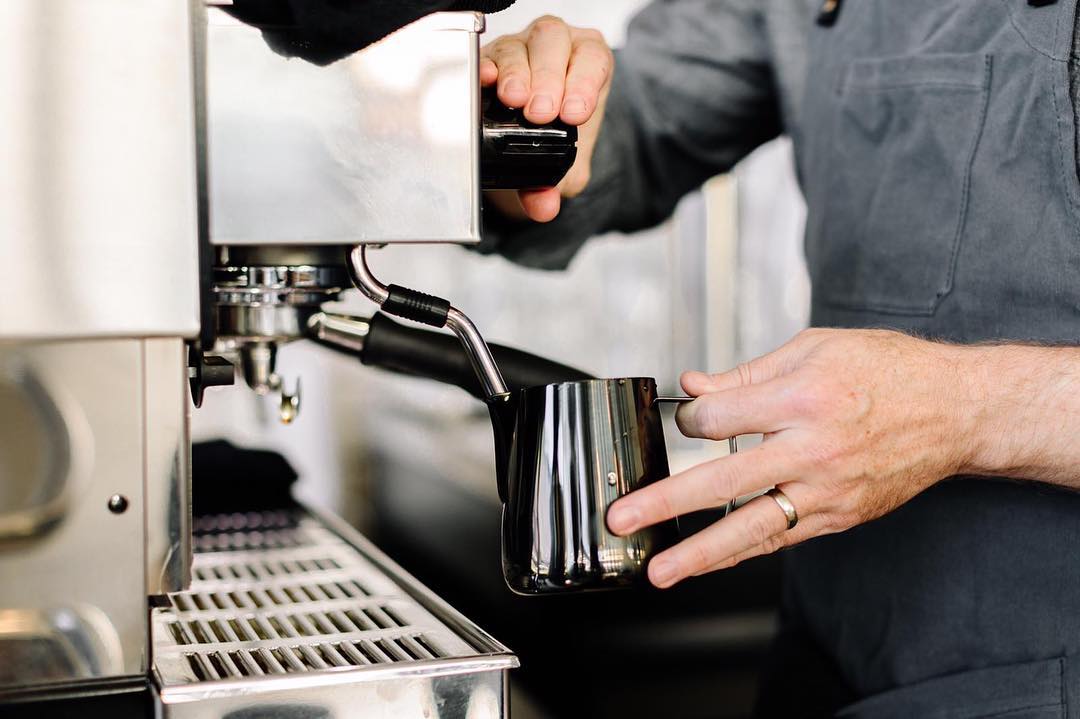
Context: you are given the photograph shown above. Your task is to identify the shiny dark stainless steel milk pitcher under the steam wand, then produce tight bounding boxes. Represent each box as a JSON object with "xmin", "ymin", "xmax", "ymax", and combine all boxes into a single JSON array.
[{"xmin": 502, "ymin": 377, "xmax": 677, "ymax": 594}]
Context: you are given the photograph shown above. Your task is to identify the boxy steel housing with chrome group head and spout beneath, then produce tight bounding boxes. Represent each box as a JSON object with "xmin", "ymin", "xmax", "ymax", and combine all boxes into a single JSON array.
[{"xmin": 206, "ymin": 8, "xmax": 484, "ymax": 414}]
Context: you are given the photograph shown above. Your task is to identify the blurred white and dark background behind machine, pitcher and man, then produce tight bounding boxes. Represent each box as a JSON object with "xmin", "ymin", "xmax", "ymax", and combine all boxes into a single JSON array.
[{"xmin": 192, "ymin": 0, "xmax": 809, "ymax": 719}]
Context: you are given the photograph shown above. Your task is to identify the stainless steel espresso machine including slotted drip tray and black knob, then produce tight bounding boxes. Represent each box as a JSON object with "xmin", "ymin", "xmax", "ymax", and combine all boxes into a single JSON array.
[{"xmin": 0, "ymin": 0, "xmax": 573, "ymax": 719}]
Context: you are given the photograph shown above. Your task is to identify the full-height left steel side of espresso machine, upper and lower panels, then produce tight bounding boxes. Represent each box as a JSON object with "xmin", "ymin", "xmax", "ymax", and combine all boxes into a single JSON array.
[{"xmin": 0, "ymin": 0, "xmax": 200, "ymax": 687}]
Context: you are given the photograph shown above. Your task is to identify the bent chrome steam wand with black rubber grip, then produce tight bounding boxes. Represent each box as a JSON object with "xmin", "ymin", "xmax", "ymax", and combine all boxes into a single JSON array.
[{"xmin": 347, "ymin": 245, "xmax": 510, "ymax": 402}]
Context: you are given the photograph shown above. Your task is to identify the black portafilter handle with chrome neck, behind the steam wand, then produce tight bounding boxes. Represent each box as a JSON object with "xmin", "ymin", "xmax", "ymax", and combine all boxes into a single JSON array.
[{"xmin": 309, "ymin": 312, "xmax": 592, "ymax": 401}]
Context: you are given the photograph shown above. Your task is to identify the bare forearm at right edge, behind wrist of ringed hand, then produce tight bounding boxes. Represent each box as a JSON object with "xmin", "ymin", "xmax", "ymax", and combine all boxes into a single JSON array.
[{"xmin": 955, "ymin": 344, "xmax": 1080, "ymax": 488}]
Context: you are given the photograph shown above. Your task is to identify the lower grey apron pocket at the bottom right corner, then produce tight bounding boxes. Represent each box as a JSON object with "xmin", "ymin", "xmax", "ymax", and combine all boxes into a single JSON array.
[{"xmin": 836, "ymin": 657, "xmax": 1067, "ymax": 719}]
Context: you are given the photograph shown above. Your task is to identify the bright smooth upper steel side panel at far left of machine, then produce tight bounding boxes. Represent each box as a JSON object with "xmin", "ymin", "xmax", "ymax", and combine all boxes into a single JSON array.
[{"xmin": 0, "ymin": 0, "xmax": 199, "ymax": 341}]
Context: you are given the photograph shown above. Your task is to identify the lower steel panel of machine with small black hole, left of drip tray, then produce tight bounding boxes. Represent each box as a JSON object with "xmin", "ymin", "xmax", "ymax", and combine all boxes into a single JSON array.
[{"xmin": 0, "ymin": 338, "xmax": 190, "ymax": 693}]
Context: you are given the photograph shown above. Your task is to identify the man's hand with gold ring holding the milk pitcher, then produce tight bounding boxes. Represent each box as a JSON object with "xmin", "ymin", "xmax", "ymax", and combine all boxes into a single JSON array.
[{"xmin": 607, "ymin": 329, "xmax": 985, "ymax": 587}]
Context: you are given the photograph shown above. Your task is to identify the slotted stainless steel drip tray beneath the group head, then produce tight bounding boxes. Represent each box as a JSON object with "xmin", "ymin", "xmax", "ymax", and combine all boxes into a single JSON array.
[{"xmin": 151, "ymin": 511, "xmax": 517, "ymax": 719}]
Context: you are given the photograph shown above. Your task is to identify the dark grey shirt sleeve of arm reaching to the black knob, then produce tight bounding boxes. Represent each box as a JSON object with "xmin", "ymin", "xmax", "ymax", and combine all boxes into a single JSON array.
[{"xmin": 480, "ymin": 0, "xmax": 782, "ymax": 270}]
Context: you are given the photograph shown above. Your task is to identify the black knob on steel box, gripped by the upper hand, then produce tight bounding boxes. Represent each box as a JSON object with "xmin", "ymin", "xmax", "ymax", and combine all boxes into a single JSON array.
[{"xmin": 480, "ymin": 87, "xmax": 578, "ymax": 190}]
